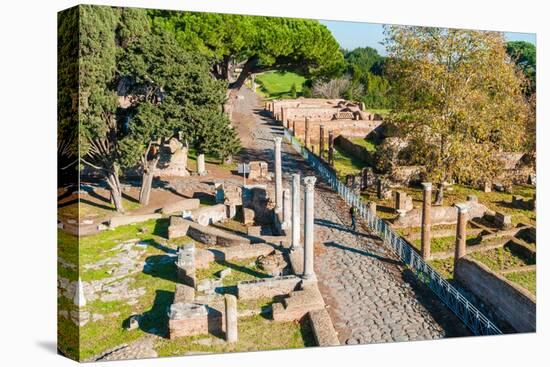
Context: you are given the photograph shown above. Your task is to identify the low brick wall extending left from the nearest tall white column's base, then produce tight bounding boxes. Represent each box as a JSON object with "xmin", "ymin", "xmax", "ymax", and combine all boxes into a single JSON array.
[{"xmin": 237, "ymin": 275, "xmax": 302, "ymax": 299}]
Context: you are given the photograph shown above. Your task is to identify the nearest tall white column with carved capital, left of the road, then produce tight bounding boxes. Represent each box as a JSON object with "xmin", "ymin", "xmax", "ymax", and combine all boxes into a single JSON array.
[{"xmin": 303, "ymin": 176, "xmax": 317, "ymax": 280}]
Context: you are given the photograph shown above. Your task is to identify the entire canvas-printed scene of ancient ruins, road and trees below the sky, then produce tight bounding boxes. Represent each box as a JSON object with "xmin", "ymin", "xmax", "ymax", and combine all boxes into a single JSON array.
[{"xmin": 57, "ymin": 5, "xmax": 537, "ymax": 362}]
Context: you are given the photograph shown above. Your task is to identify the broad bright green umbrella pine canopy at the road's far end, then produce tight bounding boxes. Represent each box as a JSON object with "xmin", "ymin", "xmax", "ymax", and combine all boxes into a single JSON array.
[{"xmin": 150, "ymin": 10, "xmax": 343, "ymax": 93}]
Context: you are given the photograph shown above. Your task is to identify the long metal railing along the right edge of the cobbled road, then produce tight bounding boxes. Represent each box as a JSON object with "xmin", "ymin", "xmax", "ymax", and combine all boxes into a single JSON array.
[{"xmin": 284, "ymin": 128, "xmax": 502, "ymax": 335}]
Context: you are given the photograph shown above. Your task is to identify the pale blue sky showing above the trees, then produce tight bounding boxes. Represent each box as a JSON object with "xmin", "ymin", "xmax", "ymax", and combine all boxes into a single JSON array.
[{"xmin": 321, "ymin": 20, "xmax": 536, "ymax": 55}]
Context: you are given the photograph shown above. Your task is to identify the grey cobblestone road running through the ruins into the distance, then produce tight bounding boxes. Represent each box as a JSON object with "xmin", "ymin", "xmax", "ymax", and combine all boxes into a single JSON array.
[{"xmin": 234, "ymin": 88, "xmax": 470, "ymax": 344}]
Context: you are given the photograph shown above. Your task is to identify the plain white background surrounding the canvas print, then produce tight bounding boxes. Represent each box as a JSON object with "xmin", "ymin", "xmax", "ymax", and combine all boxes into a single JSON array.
[{"xmin": 0, "ymin": 0, "xmax": 550, "ymax": 367}]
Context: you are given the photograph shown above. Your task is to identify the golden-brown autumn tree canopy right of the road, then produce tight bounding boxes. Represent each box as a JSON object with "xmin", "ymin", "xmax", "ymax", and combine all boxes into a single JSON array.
[{"xmin": 386, "ymin": 26, "xmax": 527, "ymax": 201}]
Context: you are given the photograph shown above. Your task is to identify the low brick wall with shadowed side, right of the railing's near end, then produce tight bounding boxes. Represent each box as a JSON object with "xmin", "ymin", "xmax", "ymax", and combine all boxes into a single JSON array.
[{"xmin": 454, "ymin": 257, "xmax": 537, "ymax": 332}]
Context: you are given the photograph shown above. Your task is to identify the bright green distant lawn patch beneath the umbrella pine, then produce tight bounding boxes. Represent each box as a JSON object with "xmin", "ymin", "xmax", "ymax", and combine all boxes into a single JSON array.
[{"xmin": 255, "ymin": 71, "xmax": 306, "ymax": 99}]
